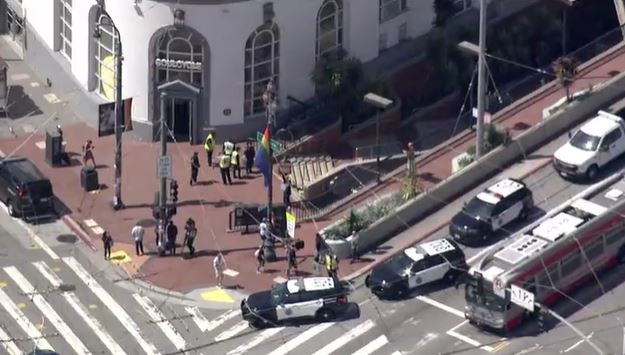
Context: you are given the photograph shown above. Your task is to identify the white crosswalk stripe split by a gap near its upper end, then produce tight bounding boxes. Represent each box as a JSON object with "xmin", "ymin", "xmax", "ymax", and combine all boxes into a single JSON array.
[{"xmin": 33, "ymin": 261, "xmax": 126, "ymax": 355}]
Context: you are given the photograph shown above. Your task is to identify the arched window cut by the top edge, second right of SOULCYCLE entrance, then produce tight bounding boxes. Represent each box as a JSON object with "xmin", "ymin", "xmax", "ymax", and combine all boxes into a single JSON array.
[{"xmin": 315, "ymin": 0, "xmax": 343, "ymax": 60}]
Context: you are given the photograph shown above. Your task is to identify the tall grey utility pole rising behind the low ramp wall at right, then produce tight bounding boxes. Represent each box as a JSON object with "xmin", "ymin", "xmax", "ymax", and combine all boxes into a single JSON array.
[{"xmin": 475, "ymin": 0, "xmax": 487, "ymax": 160}]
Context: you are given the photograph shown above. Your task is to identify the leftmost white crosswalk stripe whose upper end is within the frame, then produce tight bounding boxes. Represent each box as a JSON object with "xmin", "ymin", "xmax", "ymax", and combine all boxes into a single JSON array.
[{"xmin": 4, "ymin": 266, "xmax": 91, "ymax": 355}]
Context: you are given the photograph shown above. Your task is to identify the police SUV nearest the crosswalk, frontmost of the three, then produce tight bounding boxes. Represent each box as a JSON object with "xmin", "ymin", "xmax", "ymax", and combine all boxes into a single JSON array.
[{"xmin": 241, "ymin": 277, "xmax": 349, "ymax": 329}]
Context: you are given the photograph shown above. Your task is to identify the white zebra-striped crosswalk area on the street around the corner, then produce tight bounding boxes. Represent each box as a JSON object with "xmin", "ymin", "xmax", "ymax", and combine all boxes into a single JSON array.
[{"xmin": 0, "ymin": 257, "xmax": 396, "ymax": 355}]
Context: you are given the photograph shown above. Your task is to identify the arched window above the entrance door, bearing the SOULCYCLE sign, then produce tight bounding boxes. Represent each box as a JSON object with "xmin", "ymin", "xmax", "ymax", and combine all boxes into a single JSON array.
[{"xmin": 156, "ymin": 28, "xmax": 204, "ymax": 87}]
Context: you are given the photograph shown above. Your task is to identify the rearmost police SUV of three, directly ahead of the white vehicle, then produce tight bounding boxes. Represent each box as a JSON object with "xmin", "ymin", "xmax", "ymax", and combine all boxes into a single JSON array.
[{"xmin": 449, "ymin": 179, "xmax": 534, "ymax": 244}]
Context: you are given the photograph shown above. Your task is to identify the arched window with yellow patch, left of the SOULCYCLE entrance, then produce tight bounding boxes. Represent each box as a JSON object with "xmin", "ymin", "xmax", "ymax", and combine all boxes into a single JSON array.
[{"xmin": 95, "ymin": 15, "xmax": 119, "ymax": 101}]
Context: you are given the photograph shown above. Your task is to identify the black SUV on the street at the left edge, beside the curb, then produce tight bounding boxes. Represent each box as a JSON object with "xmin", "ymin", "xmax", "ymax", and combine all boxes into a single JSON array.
[{"xmin": 0, "ymin": 157, "xmax": 55, "ymax": 217}]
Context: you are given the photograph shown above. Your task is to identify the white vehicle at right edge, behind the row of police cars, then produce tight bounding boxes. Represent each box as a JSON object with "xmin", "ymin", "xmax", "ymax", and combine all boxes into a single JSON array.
[{"xmin": 553, "ymin": 111, "xmax": 625, "ymax": 180}]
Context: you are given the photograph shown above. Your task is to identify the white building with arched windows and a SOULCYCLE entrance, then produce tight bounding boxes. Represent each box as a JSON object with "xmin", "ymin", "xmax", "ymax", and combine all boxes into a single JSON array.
[{"xmin": 0, "ymin": 0, "xmax": 471, "ymax": 142}]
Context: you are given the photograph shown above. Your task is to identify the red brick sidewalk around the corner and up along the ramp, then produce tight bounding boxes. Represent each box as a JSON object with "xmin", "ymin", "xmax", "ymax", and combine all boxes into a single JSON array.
[{"xmin": 0, "ymin": 36, "xmax": 625, "ymax": 293}]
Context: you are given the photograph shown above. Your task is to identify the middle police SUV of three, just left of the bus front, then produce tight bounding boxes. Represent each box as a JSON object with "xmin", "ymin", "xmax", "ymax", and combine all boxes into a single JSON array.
[{"xmin": 365, "ymin": 238, "xmax": 468, "ymax": 298}]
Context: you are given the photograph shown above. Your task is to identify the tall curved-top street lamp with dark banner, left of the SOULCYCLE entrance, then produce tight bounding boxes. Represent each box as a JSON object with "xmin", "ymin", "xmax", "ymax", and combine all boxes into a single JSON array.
[{"xmin": 94, "ymin": 9, "xmax": 124, "ymax": 211}]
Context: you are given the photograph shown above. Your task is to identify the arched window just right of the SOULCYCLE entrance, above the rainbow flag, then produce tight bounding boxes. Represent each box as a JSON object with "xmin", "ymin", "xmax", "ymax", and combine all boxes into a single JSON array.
[{"xmin": 243, "ymin": 23, "xmax": 280, "ymax": 116}]
